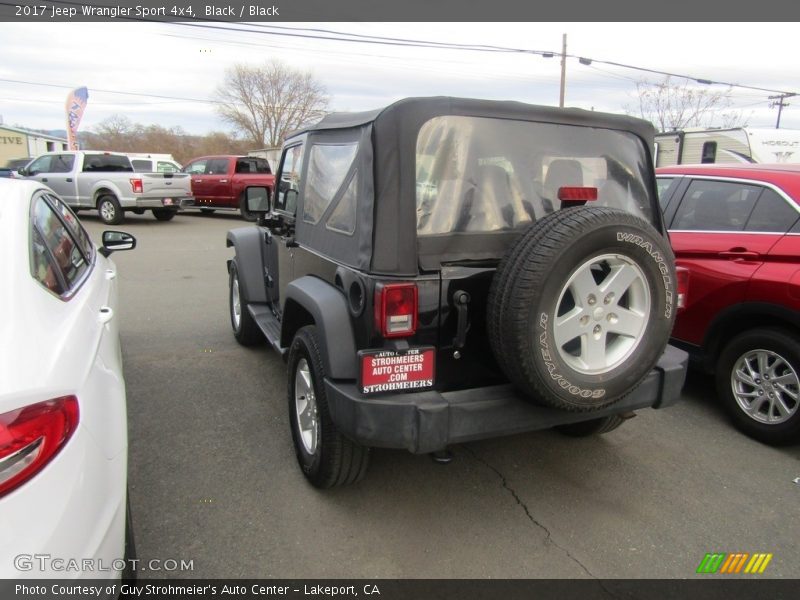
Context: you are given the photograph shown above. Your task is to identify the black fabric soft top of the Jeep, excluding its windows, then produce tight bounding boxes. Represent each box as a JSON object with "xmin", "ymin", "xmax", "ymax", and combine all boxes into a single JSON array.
[{"xmin": 286, "ymin": 96, "xmax": 655, "ymax": 275}]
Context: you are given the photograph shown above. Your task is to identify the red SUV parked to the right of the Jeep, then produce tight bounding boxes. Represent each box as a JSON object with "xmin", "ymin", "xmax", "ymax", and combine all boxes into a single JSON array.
[{"xmin": 656, "ymin": 164, "xmax": 800, "ymax": 444}]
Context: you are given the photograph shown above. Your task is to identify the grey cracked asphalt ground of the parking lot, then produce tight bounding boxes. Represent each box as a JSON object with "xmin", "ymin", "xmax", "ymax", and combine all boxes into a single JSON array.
[{"xmin": 81, "ymin": 212, "xmax": 800, "ymax": 579}]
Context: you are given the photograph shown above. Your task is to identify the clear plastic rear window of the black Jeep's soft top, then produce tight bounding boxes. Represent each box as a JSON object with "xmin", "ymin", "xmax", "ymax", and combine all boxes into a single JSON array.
[{"xmin": 416, "ymin": 116, "xmax": 654, "ymax": 236}]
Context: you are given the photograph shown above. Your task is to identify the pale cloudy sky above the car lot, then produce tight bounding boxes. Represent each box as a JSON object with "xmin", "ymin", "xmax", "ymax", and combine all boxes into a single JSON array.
[{"xmin": 0, "ymin": 23, "xmax": 800, "ymax": 134}]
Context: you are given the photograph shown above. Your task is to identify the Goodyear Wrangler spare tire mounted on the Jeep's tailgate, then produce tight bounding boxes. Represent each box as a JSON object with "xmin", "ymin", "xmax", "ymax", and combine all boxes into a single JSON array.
[{"xmin": 487, "ymin": 207, "xmax": 676, "ymax": 411}]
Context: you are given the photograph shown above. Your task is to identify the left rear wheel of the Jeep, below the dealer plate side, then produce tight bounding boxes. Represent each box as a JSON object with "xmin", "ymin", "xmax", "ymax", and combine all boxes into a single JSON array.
[{"xmin": 288, "ymin": 325, "xmax": 370, "ymax": 488}]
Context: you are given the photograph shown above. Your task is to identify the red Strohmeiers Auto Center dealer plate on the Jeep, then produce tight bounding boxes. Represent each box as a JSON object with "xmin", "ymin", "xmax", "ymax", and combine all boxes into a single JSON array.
[{"xmin": 358, "ymin": 348, "xmax": 436, "ymax": 394}]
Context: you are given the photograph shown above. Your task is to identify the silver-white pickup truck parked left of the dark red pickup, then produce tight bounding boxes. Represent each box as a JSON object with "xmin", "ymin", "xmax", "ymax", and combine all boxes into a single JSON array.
[{"xmin": 19, "ymin": 151, "xmax": 194, "ymax": 225}]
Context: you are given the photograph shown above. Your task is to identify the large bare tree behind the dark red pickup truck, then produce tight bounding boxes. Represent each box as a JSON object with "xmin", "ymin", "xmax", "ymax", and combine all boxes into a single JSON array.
[{"xmin": 216, "ymin": 61, "xmax": 329, "ymax": 148}]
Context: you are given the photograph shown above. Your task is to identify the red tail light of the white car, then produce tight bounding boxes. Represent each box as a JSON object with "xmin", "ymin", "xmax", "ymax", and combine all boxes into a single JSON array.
[{"xmin": 0, "ymin": 396, "xmax": 78, "ymax": 497}]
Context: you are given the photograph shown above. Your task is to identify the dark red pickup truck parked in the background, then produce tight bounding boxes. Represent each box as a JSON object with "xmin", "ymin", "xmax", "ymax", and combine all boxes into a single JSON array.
[{"xmin": 183, "ymin": 155, "xmax": 275, "ymax": 221}]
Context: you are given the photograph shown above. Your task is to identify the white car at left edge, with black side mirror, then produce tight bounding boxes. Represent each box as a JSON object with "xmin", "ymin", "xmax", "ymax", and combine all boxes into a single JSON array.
[{"xmin": 0, "ymin": 179, "xmax": 136, "ymax": 579}]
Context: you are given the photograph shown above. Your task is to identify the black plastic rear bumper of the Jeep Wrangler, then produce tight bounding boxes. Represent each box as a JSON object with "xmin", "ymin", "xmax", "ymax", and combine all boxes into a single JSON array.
[{"xmin": 325, "ymin": 346, "xmax": 687, "ymax": 454}]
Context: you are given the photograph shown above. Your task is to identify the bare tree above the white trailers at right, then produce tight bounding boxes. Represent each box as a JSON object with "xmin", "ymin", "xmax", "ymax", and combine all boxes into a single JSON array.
[{"xmin": 627, "ymin": 76, "xmax": 744, "ymax": 131}]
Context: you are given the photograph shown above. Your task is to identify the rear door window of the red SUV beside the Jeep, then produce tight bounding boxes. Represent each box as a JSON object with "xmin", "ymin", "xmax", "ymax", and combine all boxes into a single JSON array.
[{"xmin": 672, "ymin": 179, "xmax": 762, "ymax": 231}]
